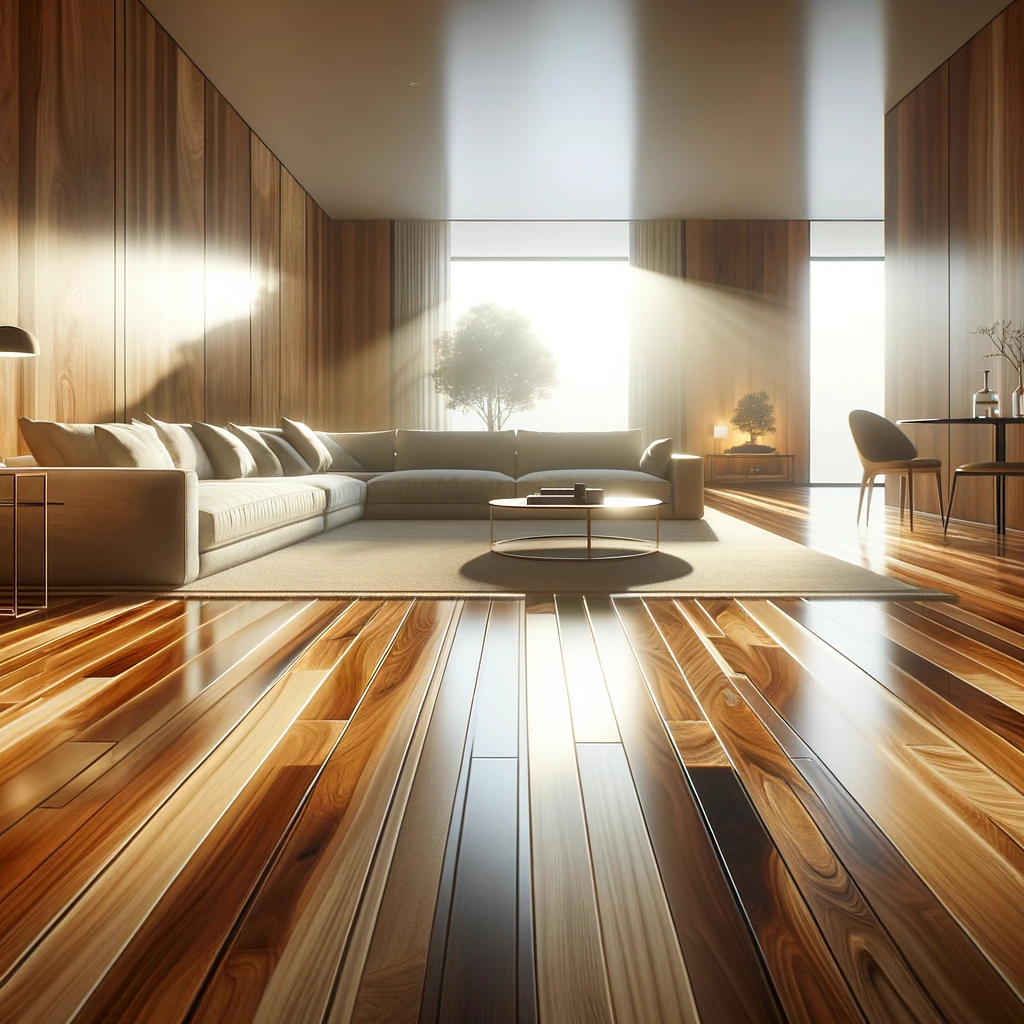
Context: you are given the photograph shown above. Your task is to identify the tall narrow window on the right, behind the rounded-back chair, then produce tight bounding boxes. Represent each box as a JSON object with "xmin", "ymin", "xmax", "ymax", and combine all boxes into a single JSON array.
[{"xmin": 810, "ymin": 221, "xmax": 885, "ymax": 483}]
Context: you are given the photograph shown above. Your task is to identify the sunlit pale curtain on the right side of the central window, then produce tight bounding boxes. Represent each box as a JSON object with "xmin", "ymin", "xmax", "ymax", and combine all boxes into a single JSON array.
[{"xmin": 630, "ymin": 220, "xmax": 687, "ymax": 452}]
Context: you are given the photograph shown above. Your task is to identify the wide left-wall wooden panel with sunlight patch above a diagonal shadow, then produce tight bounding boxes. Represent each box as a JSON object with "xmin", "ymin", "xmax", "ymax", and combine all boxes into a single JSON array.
[{"xmin": 124, "ymin": 0, "xmax": 206, "ymax": 422}]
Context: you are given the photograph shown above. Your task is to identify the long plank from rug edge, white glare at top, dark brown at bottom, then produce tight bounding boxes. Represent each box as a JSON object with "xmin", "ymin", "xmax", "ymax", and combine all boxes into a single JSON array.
[{"xmin": 587, "ymin": 598, "xmax": 780, "ymax": 1020}]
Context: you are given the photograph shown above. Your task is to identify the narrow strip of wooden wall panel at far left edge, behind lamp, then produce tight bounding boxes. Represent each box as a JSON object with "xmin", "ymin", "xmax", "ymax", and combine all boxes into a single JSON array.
[{"xmin": 0, "ymin": 0, "xmax": 25, "ymax": 457}]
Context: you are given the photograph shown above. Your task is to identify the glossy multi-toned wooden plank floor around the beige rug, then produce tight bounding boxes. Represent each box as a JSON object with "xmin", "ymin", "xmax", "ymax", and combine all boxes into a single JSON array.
[{"xmin": 0, "ymin": 488, "xmax": 1024, "ymax": 1024}]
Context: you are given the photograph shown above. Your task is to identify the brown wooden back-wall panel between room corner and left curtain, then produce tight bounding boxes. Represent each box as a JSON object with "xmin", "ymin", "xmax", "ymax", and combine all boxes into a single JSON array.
[{"xmin": 332, "ymin": 220, "xmax": 391, "ymax": 430}]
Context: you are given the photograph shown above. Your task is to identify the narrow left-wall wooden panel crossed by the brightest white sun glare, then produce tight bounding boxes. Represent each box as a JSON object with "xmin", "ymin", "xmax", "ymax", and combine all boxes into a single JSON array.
[{"xmin": 206, "ymin": 81, "xmax": 252, "ymax": 424}]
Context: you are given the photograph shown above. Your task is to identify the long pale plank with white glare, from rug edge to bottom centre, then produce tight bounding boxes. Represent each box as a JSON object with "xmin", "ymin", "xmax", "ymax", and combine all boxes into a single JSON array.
[{"xmin": 526, "ymin": 605, "xmax": 612, "ymax": 1024}]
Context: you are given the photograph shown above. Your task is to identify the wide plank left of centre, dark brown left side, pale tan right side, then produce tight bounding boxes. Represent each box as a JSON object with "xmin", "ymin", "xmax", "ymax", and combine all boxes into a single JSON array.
[{"xmin": 195, "ymin": 602, "xmax": 454, "ymax": 1022}]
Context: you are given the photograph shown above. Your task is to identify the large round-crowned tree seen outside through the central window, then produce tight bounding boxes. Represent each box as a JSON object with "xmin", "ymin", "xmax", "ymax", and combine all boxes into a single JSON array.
[{"xmin": 433, "ymin": 302, "xmax": 558, "ymax": 430}]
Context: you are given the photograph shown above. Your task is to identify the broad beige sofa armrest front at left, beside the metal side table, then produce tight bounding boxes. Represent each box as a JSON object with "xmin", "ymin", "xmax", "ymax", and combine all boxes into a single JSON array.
[{"xmin": 12, "ymin": 467, "xmax": 199, "ymax": 589}]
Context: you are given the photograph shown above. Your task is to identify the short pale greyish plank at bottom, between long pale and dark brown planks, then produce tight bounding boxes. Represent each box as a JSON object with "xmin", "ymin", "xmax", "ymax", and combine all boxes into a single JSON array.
[{"xmin": 577, "ymin": 743, "xmax": 698, "ymax": 1024}]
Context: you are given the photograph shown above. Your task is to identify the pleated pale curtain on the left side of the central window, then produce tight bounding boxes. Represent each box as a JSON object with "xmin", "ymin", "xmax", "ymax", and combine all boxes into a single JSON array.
[{"xmin": 391, "ymin": 220, "xmax": 452, "ymax": 430}]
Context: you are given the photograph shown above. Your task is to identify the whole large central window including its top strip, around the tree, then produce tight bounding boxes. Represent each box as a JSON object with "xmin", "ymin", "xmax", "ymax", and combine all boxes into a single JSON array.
[{"xmin": 451, "ymin": 222, "xmax": 630, "ymax": 430}]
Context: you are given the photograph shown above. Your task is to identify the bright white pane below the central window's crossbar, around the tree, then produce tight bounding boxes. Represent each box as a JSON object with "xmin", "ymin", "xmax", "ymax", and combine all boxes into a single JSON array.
[{"xmin": 450, "ymin": 257, "xmax": 631, "ymax": 430}]
